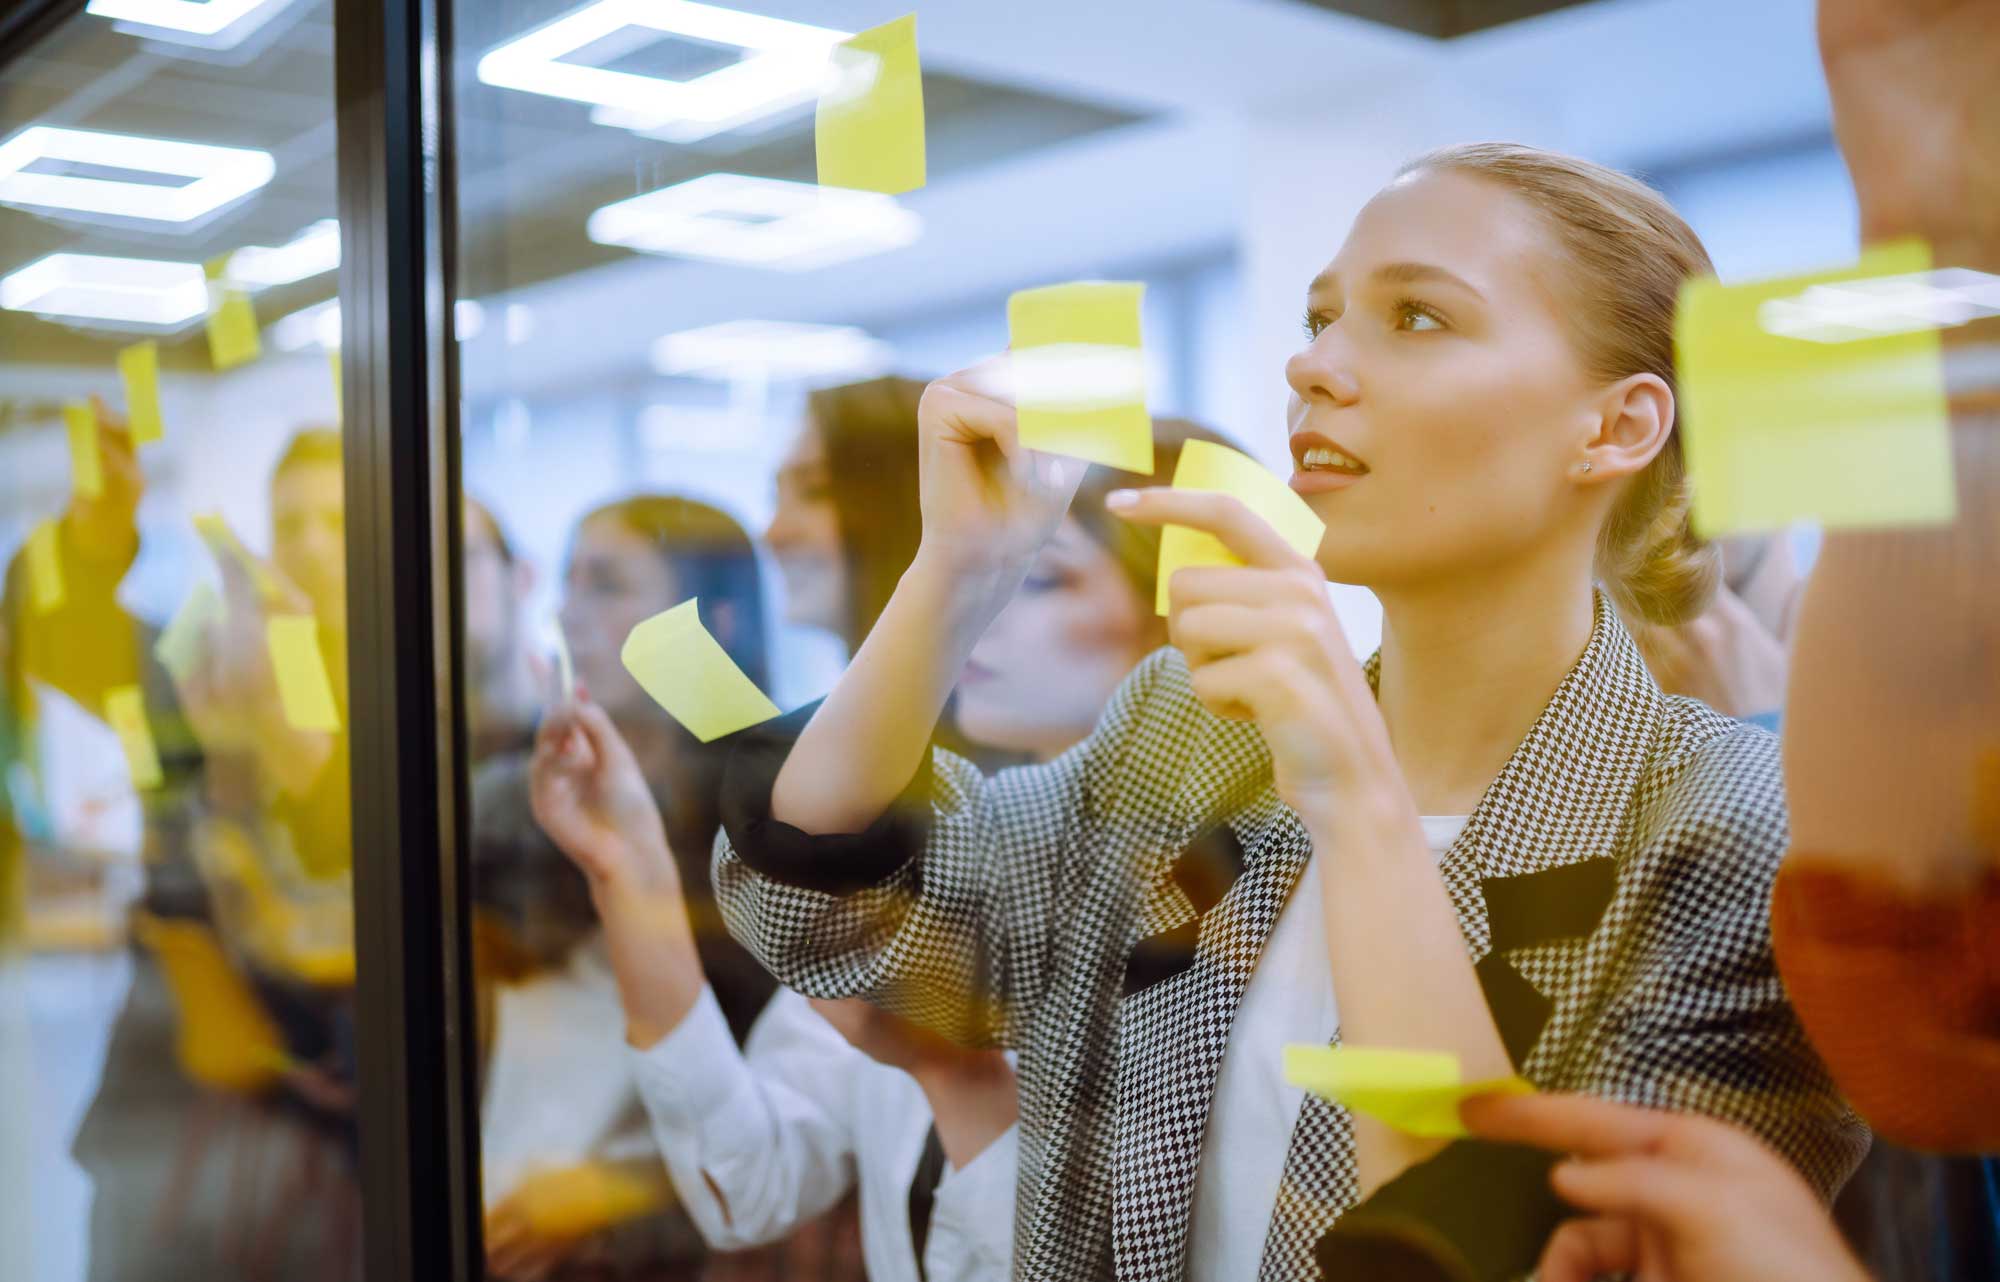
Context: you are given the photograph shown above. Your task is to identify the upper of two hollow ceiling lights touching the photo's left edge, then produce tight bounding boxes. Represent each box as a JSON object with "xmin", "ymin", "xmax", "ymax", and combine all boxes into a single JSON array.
[{"xmin": 0, "ymin": 124, "xmax": 278, "ymax": 222}]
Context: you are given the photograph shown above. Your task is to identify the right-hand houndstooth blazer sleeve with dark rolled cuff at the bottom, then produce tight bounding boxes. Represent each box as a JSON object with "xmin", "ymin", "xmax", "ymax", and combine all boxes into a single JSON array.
[{"xmin": 1320, "ymin": 726, "xmax": 1868, "ymax": 1282}]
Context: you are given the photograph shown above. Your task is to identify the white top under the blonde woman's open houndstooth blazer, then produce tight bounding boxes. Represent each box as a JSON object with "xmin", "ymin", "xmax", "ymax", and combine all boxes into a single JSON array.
[{"xmin": 1188, "ymin": 814, "xmax": 1470, "ymax": 1282}]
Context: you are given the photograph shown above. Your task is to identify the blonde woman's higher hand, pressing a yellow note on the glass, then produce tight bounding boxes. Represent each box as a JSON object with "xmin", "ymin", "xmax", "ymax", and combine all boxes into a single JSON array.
[{"xmin": 916, "ymin": 356, "xmax": 1086, "ymax": 590}]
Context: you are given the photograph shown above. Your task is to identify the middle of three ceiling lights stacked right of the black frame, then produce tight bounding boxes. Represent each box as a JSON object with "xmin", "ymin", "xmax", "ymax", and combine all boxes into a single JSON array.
[{"xmin": 586, "ymin": 174, "xmax": 924, "ymax": 272}]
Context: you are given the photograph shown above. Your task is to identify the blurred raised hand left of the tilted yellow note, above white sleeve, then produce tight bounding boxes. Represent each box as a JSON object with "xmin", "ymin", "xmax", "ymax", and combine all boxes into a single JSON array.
[{"xmin": 528, "ymin": 698, "xmax": 678, "ymax": 890}]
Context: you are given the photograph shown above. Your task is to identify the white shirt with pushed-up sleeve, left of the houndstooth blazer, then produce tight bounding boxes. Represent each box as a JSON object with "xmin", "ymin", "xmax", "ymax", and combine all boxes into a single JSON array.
[{"xmin": 632, "ymin": 988, "xmax": 1016, "ymax": 1282}]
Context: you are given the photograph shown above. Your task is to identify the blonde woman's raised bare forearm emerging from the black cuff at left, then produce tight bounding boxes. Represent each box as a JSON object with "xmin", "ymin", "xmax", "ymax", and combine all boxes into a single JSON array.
[{"xmin": 770, "ymin": 554, "xmax": 1012, "ymax": 834}]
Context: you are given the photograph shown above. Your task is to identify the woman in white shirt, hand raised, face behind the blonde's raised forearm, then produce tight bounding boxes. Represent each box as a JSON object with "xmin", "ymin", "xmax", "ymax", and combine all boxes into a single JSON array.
[{"xmin": 534, "ymin": 420, "xmax": 1220, "ymax": 1282}]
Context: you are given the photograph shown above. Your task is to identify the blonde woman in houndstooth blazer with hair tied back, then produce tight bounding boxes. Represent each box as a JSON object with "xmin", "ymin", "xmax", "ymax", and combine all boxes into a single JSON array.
[{"xmin": 696, "ymin": 144, "xmax": 1866, "ymax": 1280}]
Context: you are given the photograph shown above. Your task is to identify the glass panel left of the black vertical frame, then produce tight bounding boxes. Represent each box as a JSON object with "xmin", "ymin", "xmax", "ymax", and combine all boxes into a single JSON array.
[{"xmin": 0, "ymin": 0, "xmax": 364, "ymax": 1282}]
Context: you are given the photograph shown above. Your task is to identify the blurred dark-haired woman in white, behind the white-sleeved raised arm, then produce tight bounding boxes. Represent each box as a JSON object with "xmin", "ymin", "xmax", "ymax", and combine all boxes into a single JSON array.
[{"xmin": 468, "ymin": 494, "xmax": 776, "ymax": 1282}]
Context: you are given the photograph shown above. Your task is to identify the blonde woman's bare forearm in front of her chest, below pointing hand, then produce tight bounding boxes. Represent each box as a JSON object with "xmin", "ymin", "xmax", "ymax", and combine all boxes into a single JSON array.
[{"xmin": 1312, "ymin": 786, "xmax": 1514, "ymax": 1196}]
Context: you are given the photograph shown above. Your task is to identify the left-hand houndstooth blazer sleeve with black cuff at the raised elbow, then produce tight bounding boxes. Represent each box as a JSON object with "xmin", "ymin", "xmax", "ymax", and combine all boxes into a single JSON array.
[{"xmin": 714, "ymin": 650, "xmax": 1186, "ymax": 1046}]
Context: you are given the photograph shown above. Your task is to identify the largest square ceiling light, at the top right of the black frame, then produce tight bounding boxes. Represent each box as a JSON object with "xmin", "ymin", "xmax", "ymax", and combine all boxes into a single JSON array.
[{"xmin": 478, "ymin": 0, "xmax": 848, "ymax": 142}]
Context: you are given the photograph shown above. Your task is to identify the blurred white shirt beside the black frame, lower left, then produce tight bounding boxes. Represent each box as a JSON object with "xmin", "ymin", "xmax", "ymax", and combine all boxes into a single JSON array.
[{"xmin": 480, "ymin": 936, "xmax": 650, "ymax": 1206}]
